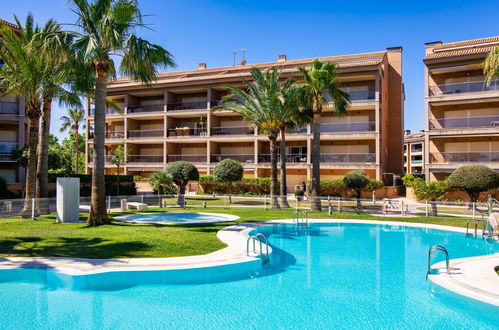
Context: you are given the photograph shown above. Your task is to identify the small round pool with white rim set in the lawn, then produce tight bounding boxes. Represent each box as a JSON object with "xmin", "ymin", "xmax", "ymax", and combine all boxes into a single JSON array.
[{"xmin": 114, "ymin": 212, "xmax": 239, "ymax": 224}]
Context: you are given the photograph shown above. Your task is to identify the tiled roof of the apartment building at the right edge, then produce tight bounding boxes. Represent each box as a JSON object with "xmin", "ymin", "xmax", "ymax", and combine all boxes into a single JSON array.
[{"xmin": 424, "ymin": 36, "xmax": 499, "ymax": 61}]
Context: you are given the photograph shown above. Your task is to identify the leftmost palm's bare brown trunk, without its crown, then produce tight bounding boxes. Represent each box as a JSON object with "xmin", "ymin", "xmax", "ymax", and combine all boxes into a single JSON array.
[{"xmin": 19, "ymin": 109, "xmax": 40, "ymax": 218}]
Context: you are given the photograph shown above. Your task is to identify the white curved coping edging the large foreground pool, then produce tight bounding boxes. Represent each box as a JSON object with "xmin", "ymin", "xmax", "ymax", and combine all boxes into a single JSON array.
[{"xmin": 0, "ymin": 219, "xmax": 499, "ymax": 306}]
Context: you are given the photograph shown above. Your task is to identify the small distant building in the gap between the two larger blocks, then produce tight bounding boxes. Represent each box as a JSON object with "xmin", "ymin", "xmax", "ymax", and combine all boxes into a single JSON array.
[{"xmin": 404, "ymin": 130, "xmax": 425, "ymax": 176}]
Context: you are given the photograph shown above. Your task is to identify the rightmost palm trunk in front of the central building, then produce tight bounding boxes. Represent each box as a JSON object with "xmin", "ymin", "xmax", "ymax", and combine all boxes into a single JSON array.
[{"xmin": 311, "ymin": 112, "xmax": 322, "ymax": 211}]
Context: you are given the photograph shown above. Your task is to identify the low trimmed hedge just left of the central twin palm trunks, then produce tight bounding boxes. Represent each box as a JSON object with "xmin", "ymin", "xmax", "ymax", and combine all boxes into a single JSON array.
[{"xmin": 198, "ymin": 175, "xmax": 271, "ymax": 195}]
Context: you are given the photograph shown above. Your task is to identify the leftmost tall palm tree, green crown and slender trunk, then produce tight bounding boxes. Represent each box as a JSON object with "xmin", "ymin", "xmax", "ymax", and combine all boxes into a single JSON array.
[{"xmin": 0, "ymin": 14, "xmax": 45, "ymax": 217}]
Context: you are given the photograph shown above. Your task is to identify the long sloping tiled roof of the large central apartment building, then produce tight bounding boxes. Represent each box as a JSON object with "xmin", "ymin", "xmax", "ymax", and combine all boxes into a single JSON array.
[{"xmin": 109, "ymin": 51, "xmax": 386, "ymax": 88}]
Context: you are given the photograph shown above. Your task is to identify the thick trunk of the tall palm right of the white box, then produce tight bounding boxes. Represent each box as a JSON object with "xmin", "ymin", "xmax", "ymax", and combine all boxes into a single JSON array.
[{"xmin": 87, "ymin": 69, "xmax": 109, "ymax": 226}]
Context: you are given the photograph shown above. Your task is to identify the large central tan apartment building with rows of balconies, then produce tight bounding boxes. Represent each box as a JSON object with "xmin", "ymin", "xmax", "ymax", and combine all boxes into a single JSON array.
[{"xmin": 86, "ymin": 47, "xmax": 404, "ymax": 189}]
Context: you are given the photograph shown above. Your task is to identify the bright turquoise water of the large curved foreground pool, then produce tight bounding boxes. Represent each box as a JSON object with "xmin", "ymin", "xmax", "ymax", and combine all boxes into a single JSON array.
[{"xmin": 0, "ymin": 224, "xmax": 499, "ymax": 329}]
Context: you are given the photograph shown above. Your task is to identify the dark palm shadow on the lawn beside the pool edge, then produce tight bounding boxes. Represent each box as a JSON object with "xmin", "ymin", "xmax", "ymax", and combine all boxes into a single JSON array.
[{"xmin": 0, "ymin": 236, "xmax": 150, "ymax": 259}]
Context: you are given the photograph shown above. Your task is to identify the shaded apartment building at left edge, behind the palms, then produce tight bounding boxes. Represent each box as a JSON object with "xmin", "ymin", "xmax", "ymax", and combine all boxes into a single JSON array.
[{"xmin": 0, "ymin": 20, "xmax": 28, "ymax": 183}]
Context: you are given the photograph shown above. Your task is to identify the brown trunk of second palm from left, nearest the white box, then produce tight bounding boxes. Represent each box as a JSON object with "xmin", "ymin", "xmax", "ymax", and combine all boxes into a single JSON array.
[{"xmin": 36, "ymin": 98, "xmax": 52, "ymax": 214}]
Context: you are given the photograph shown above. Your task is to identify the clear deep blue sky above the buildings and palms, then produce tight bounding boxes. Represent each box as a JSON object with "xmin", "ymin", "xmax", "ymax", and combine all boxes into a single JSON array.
[{"xmin": 0, "ymin": 0, "xmax": 499, "ymax": 138}]
